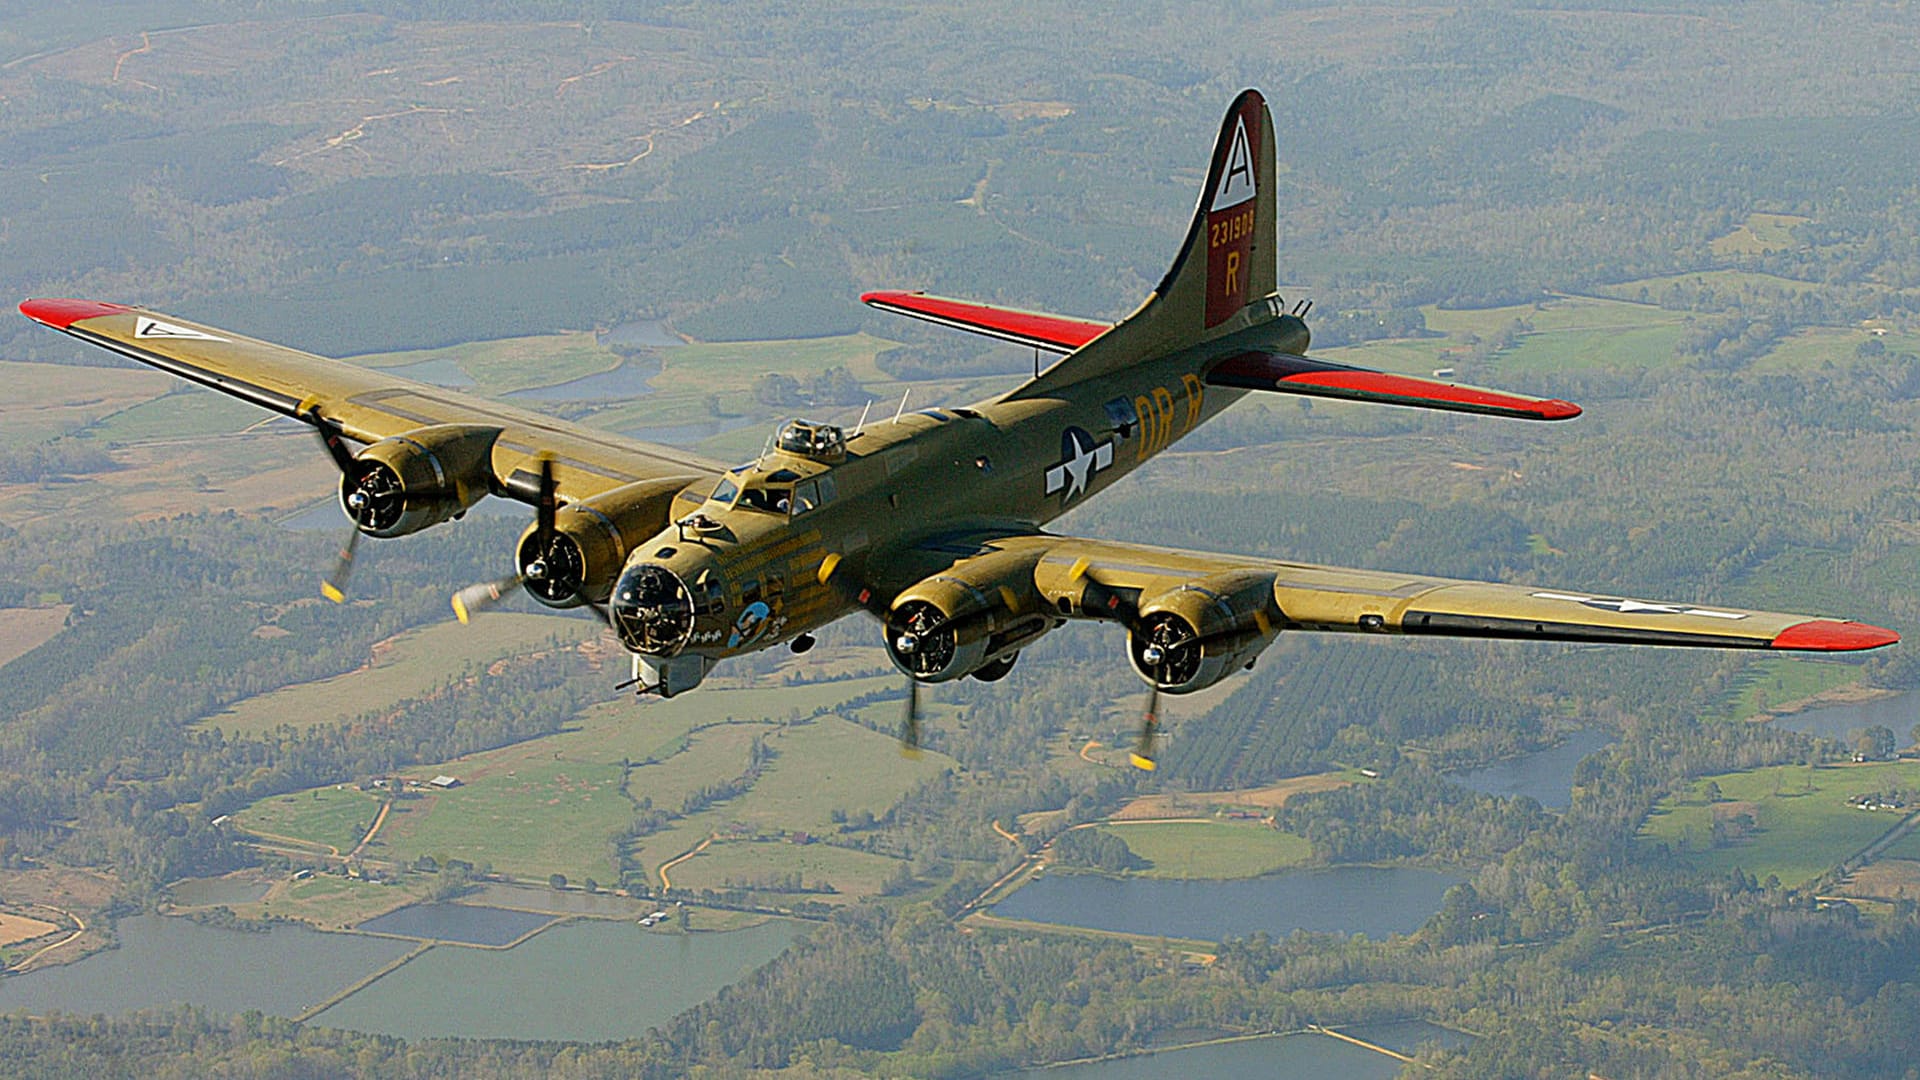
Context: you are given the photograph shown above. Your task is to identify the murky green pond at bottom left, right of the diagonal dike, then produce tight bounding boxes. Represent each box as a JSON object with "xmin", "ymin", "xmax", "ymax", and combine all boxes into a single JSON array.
[{"xmin": 313, "ymin": 920, "xmax": 803, "ymax": 1042}]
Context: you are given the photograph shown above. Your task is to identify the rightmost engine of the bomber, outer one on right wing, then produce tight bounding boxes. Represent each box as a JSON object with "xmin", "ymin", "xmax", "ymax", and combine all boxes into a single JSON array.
[{"xmin": 1127, "ymin": 571, "xmax": 1281, "ymax": 694}]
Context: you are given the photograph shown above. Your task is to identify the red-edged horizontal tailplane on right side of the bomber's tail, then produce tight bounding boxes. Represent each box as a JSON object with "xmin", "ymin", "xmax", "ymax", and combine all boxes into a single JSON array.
[{"xmin": 1206, "ymin": 352, "xmax": 1580, "ymax": 421}]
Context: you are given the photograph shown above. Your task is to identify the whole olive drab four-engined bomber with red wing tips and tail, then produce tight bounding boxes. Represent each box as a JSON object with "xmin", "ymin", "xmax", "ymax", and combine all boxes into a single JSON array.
[{"xmin": 21, "ymin": 90, "xmax": 1899, "ymax": 769}]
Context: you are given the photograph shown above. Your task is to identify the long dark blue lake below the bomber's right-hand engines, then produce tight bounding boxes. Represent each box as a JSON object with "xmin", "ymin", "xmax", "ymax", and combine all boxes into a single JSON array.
[{"xmin": 993, "ymin": 867, "xmax": 1463, "ymax": 942}]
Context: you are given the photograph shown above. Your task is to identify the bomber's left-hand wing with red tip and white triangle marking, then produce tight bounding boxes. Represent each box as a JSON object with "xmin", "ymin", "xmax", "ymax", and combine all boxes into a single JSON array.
[{"xmin": 19, "ymin": 300, "xmax": 722, "ymax": 502}]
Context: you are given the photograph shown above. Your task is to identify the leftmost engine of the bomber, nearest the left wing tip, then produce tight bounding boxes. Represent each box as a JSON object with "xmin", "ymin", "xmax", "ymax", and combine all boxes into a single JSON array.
[{"xmin": 340, "ymin": 425, "xmax": 499, "ymax": 536}]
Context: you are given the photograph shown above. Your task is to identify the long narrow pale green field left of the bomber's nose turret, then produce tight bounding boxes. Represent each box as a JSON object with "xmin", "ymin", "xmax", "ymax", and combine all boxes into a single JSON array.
[{"xmin": 202, "ymin": 611, "xmax": 597, "ymax": 736}]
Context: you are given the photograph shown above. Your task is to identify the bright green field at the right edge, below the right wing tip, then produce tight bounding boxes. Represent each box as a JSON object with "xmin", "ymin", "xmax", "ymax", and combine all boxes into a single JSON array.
[{"xmin": 1640, "ymin": 761, "xmax": 1920, "ymax": 886}]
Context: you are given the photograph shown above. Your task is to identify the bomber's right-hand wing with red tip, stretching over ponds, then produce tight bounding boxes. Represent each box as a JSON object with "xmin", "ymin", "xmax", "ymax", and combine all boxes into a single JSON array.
[{"xmin": 1006, "ymin": 536, "xmax": 1899, "ymax": 651}]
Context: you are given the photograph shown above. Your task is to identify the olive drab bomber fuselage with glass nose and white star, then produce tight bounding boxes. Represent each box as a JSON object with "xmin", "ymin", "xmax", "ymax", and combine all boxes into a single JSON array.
[{"xmin": 611, "ymin": 315, "xmax": 1308, "ymax": 680}]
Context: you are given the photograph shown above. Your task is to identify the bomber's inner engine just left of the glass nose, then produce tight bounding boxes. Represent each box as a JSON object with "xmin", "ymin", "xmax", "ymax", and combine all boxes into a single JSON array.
[{"xmin": 515, "ymin": 477, "xmax": 695, "ymax": 607}]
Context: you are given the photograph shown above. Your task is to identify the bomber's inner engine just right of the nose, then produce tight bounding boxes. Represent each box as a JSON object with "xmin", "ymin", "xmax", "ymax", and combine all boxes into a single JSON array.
[{"xmin": 887, "ymin": 550, "xmax": 1062, "ymax": 682}]
